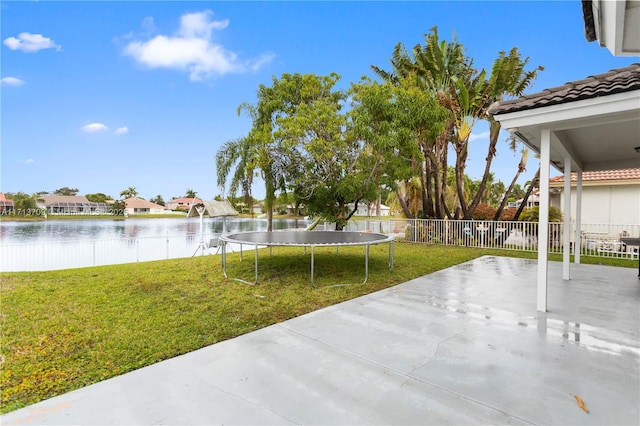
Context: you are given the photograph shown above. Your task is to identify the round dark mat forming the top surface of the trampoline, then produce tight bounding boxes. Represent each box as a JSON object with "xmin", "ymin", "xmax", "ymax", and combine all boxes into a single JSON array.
[{"xmin": 222, "ymin": 231, "xmax": 393, "ymax": 246}]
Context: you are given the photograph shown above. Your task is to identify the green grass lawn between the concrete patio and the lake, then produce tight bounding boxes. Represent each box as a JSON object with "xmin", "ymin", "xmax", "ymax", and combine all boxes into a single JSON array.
[{"xmin": 0, "ymin": 243, "xmax": 636, "ymax": 413}]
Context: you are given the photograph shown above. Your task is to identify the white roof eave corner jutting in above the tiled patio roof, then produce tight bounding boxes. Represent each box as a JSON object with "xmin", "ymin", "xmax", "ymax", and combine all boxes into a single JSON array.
[{"xmin": 582, "ymin": 0, "xmax": 640, "ymax": 56}]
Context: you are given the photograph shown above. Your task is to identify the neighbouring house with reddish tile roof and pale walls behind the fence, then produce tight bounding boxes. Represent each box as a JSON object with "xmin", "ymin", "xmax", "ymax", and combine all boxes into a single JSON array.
[{"xmin": 549, "ymin": 168, "xmax": 640, "ymax": 225}]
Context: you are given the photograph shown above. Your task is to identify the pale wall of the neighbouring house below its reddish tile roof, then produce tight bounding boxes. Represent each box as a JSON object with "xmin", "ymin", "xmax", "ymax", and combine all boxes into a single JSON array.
[{"xmin": 550, "ymin": 184, "xmax": 640, "ymax": 225}]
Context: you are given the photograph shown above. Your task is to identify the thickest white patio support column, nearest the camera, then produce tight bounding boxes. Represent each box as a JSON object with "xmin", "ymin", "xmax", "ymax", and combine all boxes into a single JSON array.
[{"xmin": 536, "ymin": 129, "xmax": 551, "ymax": 312}]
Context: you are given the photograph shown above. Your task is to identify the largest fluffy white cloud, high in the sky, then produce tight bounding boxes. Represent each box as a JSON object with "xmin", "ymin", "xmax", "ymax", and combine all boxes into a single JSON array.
[{"xmin": 123, "ymin": 10, "xmax": 274, "ymax": 81}]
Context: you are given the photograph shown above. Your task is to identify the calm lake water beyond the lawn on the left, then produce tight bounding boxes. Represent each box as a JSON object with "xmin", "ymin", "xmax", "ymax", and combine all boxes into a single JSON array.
[{"xmin": 0, "ymin": 218, "xmax": 307, "ymax": 271}]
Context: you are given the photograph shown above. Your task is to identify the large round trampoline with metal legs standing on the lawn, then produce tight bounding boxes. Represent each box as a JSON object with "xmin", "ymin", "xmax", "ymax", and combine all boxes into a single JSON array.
[{"xmin": 220, "ymin": 231, "xmax": 394, "ymax": 288}]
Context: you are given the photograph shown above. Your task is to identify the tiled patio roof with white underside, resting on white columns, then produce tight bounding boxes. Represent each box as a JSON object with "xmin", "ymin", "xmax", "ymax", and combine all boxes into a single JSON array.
[{"xmin": 489, "ymin": 64, "xmax": 640, "ymax": 172}]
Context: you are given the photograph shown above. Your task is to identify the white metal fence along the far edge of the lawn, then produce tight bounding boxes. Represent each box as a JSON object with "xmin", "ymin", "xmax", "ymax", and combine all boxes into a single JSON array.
[{"xmin": 0, "ymin": 219, "xmax": 640, "ymax": 272}]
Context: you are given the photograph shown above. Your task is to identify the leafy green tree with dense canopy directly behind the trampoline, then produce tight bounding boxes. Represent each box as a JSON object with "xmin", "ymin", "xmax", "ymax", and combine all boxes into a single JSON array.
[{"xmin": 273, "ymin": 74, "xmax": 382, "ymax": 230}]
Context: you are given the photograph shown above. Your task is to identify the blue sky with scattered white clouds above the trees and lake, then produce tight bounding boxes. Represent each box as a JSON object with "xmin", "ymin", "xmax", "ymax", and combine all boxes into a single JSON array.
[{"xmin": 0, "ymin": 1, "xmax": 638, "ymax": 200}]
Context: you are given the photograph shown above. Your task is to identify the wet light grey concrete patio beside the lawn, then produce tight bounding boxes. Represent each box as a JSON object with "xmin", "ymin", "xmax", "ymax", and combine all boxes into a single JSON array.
[{"xmin": 0, "ymin": 257, "xmax": 640, "ymax": 425}]
